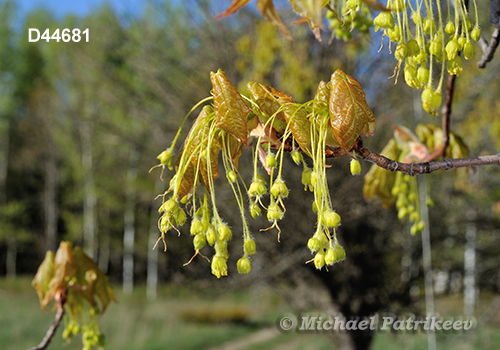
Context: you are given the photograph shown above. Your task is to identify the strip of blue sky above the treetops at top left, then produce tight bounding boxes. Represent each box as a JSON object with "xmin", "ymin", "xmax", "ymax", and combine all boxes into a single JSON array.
[{"xmin": 15, "ymin": 0, "xmax": 147, "ymax": 17}]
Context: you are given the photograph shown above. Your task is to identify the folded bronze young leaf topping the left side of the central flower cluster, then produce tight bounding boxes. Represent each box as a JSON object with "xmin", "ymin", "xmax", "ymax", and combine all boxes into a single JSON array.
[{"xmin": 210, "ymin": 69, "xmax": 251, "ymax": 146}]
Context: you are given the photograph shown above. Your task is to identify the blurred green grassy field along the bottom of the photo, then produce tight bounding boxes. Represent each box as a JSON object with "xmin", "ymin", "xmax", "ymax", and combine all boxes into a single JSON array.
[{"xmin": 0, "ymin": 278, "xmax": 500, "ymax": 350}]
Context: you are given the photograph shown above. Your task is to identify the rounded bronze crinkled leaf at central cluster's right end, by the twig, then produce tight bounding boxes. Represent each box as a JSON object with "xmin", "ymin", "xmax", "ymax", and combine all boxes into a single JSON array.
[{"xmin": 329, "ymin": 69, "xmax": 375, "ymax": 153}]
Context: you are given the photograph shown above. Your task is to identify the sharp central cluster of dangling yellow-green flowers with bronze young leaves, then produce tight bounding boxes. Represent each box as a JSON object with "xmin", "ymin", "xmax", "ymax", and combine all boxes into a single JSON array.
[{"xmin": 158, "ymin": 70, "xmax": 375, "ymax": 277}]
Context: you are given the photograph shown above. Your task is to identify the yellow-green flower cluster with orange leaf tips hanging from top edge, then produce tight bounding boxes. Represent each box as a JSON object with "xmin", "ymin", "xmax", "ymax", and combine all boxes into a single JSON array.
[{"xmin": 218, "ymin": 0, "xmax": 481, "ymax": 115}]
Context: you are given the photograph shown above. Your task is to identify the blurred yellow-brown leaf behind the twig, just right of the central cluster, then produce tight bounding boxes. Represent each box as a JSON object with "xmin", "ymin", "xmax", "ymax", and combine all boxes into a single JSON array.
[{"xmin": 363, "ymin": 138, "xmax": 401, "ymax": 209}]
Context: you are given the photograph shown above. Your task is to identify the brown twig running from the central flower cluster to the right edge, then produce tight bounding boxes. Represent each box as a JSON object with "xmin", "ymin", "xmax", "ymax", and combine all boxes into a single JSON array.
[{"xmin": 353, "ymin": 138, "xmax": 500, "ymax": 176}]
